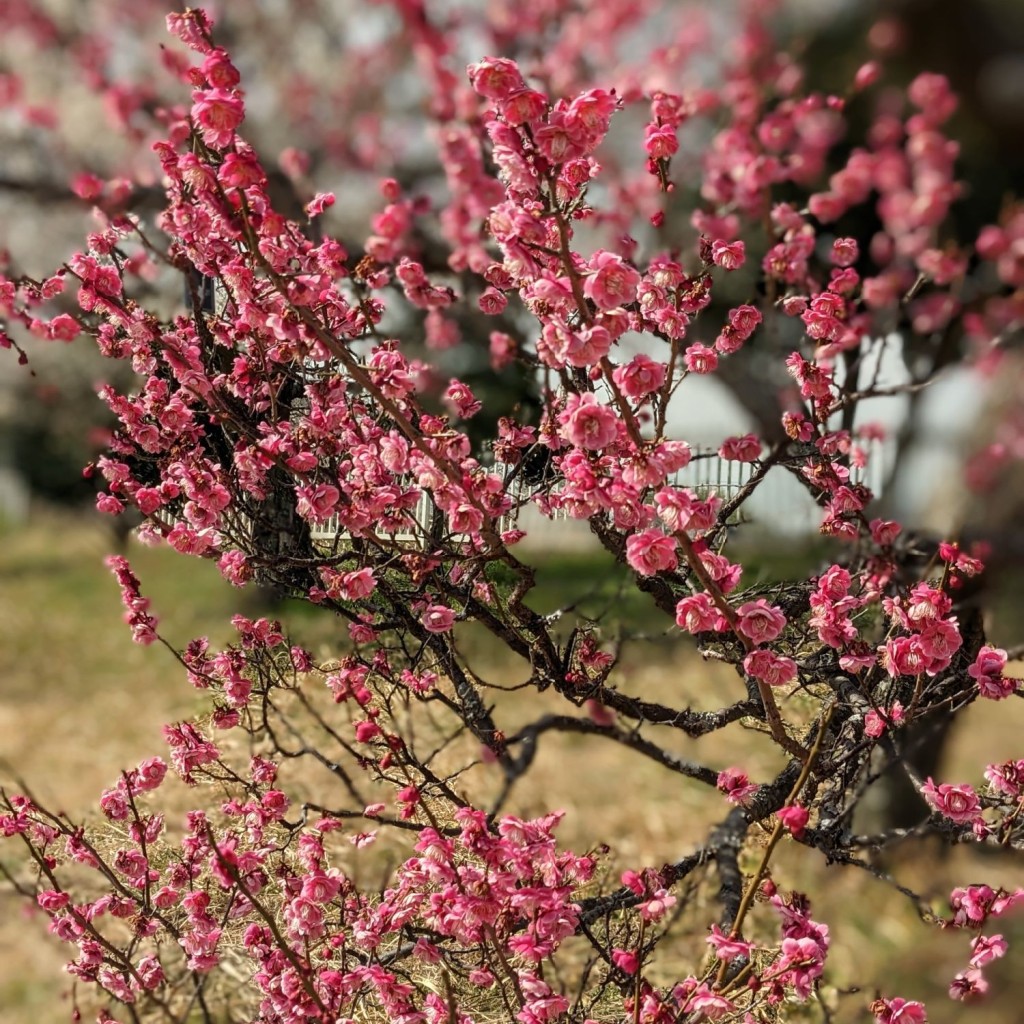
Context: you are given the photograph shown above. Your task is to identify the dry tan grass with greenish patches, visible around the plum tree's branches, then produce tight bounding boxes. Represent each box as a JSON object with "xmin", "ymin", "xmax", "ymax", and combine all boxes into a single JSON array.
[{"xmin": 0, "ymin": 519, "xmax": 1024, "ymax": 1024}]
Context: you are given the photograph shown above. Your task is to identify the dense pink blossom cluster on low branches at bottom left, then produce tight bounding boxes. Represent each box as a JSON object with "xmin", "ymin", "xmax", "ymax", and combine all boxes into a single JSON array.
[{"xmin": 0, "ymin": 774, "xmax": 595, "ymax": 1022}]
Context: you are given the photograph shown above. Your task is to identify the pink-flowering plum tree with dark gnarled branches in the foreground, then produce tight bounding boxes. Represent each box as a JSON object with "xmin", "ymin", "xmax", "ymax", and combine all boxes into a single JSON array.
[{"xmin": 0, "ymin": 0, "xmax": 1024, "ymax": 1024}]
